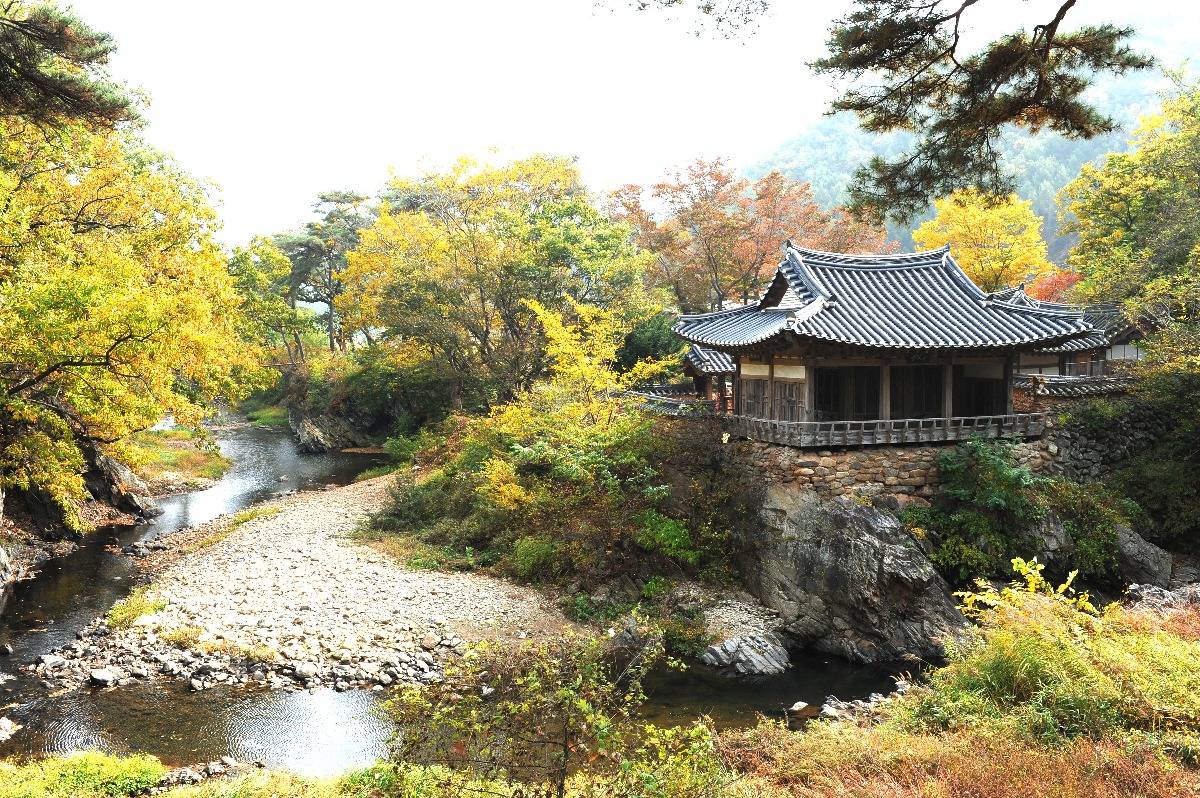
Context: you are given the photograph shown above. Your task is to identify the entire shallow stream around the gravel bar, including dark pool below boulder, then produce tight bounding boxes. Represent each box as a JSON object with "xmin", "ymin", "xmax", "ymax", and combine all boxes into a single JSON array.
[{"xmin": 0, "ymin": 425, "xmax": 900, "ymax": 775}]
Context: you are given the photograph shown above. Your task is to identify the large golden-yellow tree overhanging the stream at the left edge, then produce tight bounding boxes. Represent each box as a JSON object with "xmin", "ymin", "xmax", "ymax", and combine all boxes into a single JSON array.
[{"xmin": 0, "ymin": 119, "xmax": 257, "ymax": 526}]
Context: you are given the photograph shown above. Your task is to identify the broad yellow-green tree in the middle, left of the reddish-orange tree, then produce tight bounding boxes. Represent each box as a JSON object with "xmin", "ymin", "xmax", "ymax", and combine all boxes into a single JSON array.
[{"xmin": 335, "ymin": 157, "xmax": 653, "ymax": 407}]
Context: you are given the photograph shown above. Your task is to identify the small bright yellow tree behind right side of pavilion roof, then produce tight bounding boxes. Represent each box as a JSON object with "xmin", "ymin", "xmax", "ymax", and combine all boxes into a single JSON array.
[{"xmin": 912, "ymin": 190, "xmax": 1051, "ymax": 292}]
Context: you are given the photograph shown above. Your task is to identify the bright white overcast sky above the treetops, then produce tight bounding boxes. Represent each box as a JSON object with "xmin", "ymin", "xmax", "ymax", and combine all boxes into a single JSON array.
[{"xmin": 71, "ymin": 0, "xmax": 1200, "ymax": 244}]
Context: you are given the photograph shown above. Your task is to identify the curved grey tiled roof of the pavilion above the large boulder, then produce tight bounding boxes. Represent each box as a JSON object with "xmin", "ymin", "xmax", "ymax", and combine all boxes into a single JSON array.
[{"xmin": 674, "ymin": 245, "xmax": 1091, "ymax": 349}]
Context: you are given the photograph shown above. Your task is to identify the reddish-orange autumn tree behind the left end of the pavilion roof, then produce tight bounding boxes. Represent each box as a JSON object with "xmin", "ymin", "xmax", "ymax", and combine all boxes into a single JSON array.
[{"xmin": 612, "ymin": 160, "xmax": 888, "ymax": 312}]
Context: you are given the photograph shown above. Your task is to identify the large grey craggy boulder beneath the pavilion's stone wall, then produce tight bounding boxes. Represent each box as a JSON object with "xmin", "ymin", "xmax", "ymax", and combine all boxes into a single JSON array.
[{"xmin": 743, "ymin": 485, "xmax": 966, "ymax": 662}]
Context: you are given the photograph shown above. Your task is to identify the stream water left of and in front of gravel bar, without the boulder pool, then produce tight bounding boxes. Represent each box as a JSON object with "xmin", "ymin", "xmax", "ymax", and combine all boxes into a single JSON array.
[{"xmin": 0, "ymin": 425, "xmax": 385, "ymax": 773}]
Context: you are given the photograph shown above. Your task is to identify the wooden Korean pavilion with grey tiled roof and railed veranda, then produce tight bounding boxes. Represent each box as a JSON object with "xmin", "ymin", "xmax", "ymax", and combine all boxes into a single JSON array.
[{"xmin": 674, "ymin": 242, "xmax": 1094, "ymax": 446}]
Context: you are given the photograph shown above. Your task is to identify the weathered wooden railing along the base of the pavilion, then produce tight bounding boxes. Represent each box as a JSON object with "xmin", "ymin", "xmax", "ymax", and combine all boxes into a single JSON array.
[{"xmin": 724, "ymin": 413, "xmax": 1046, "ymax": 449}]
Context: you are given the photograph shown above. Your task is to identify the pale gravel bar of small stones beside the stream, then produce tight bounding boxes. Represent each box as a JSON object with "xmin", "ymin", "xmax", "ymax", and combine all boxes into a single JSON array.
[{"xmin": 28, "ymin": 476, "xmax": 568, "ymax": 689}]
